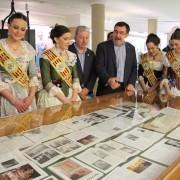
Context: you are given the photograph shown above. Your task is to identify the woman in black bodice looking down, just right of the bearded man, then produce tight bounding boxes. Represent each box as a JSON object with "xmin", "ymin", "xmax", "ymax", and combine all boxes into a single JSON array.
[{"xmin": 138, "ymin": 33, "xmax": 172, "ymax": 103}]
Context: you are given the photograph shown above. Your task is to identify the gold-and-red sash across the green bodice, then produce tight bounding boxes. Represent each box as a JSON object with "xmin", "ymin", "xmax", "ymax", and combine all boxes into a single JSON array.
[{"xmin": 43, "ymin": 49, "xmax": 72, "ymax": 88}]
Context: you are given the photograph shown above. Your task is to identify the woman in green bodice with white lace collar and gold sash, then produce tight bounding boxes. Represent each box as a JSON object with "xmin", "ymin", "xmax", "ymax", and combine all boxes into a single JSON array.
[{"xmin": 38, "ymin": 25, "xmax": 81, "ymax": 107}]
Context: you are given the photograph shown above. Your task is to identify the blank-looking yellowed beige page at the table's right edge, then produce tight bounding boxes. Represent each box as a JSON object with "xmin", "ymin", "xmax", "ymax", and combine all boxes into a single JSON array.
[{"xmin": 142, "ymin": 108, "xmax": 180, "ymax": 134}]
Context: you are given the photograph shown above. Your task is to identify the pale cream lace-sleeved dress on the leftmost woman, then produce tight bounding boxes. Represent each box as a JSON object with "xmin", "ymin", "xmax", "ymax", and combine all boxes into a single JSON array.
[{"xmin": 0, "ymin": 39, "xmax": 39, "ymax": 117}]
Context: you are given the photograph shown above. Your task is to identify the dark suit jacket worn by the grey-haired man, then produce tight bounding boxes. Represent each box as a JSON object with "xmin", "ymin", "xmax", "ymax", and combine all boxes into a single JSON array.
[{"xmin": 69, "ymin": 43, "xmax": 96, "ymax": 92}]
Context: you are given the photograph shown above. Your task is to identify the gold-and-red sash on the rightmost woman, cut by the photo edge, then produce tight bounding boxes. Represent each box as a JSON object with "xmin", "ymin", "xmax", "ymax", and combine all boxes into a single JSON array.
[{"xmin": 166, "ymin": 51, "xmax": 180, "ymax": 78}]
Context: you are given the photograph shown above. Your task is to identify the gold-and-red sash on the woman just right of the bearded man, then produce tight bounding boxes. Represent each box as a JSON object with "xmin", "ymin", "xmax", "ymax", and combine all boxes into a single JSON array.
[{"xmin": 141, "ymin": 53, "xmax": 157, "ymax": 104}]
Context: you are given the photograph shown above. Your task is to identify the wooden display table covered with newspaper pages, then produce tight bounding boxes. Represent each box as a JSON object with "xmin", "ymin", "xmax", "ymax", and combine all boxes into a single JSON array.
[{"xmin": 0, "ymin": 93, "xmax": 180, "ymax": 180}]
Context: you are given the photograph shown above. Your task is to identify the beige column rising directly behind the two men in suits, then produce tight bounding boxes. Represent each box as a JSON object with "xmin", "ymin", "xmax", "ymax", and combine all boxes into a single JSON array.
[{"xmin": 91, "ymin": 3, "xmax": 105, "ymax": 52}]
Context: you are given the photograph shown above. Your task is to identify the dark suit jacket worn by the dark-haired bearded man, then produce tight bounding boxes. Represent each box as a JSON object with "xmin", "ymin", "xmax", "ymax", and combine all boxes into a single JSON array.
[{"xmin": 96, "ymin": 40, "xmax": 137, "ymax": 95}]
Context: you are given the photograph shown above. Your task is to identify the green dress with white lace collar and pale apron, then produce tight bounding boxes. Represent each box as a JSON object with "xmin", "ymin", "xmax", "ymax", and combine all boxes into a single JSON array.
[{"xmin": 37, "ymin": 47, "xmax": 81, "ymax": 108}]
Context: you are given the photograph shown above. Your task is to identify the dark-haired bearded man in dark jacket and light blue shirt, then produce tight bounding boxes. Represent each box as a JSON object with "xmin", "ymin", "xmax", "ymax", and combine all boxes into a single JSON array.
[{"xmin": 96, "ymin": 22, "xmax": 137, "ymax": 96}]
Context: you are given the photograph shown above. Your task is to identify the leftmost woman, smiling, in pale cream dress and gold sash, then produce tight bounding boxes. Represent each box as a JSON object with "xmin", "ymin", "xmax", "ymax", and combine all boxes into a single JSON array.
[{"xmin": 0, "ymin": 13, "xmax": 39, "ymax": 117}]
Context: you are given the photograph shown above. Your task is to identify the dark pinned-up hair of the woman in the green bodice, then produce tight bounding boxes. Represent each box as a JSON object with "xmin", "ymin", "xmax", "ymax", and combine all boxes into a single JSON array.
[{"xmin": 50, "ymin": 24, "xmax": 70, "ymax": 44}]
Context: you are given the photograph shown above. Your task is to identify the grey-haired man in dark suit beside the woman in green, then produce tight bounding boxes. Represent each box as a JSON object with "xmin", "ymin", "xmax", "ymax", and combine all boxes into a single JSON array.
[{"xmin": 69, "ymin": 26, "xmax": 96, "ymax": 99}]
